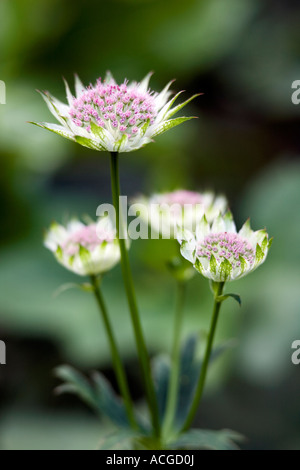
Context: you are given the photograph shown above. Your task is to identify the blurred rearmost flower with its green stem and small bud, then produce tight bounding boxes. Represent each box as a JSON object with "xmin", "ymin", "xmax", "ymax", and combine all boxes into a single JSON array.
[{"xmin": 133, "ymin": 189, "xmax": 228, "ymax": 438}]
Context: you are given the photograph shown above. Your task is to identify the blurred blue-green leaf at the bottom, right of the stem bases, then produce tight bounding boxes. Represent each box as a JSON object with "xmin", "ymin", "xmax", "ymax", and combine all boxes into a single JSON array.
[{"xmin": 170, "ymin": 429, "xmax": 243, "ymax": 450}]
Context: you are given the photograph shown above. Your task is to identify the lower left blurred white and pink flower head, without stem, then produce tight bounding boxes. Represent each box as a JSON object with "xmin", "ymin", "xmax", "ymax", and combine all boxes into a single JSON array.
[{"xmin": 44, "ymin": 217, "xmax": 120, "ymax": 276}]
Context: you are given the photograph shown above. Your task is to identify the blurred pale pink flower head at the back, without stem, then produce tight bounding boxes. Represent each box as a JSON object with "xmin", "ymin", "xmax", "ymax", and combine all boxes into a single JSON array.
[{"xmin": 134, "ymin": 190, "xmax": 228, "ymax": 238}]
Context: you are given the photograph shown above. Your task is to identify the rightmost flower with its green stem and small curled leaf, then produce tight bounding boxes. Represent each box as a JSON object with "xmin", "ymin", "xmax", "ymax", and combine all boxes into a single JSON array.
[{"xmin": 178, "ymin": 212, "xmax": 272, "ymax": 431}]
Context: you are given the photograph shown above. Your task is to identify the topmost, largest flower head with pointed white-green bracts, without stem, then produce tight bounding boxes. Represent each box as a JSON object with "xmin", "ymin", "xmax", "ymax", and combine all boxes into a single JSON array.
[{"xmin": 33, "ymin": 73, "xmax": 198, "ymax": 152}]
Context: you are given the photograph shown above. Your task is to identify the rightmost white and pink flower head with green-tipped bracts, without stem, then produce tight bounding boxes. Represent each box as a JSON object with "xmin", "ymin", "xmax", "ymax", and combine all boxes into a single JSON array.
[{"xmin": 178, "ymin": 212, "xmax": 272, "ymax": 282}]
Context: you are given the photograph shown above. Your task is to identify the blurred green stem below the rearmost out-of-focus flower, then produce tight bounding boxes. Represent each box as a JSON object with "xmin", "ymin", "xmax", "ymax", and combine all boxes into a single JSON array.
[{"xmin": 162, "ymin": 281, "xmax": 186, "ymax": 439}]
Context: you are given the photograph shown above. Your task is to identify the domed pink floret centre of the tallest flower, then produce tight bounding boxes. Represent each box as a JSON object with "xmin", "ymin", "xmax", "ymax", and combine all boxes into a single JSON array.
[{"xmin": 70, "ymin": 79, "xmax": 157, "ymax": 138}]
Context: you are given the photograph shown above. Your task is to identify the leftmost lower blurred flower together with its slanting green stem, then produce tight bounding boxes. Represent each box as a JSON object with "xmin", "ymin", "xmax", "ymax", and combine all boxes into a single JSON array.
[{"xmin": 44, "ymin": 217, "xmax": 137, "ymax": 428}]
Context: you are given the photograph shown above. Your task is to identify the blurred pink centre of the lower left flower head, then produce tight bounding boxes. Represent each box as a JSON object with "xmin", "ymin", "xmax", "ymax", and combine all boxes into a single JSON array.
[{"xmin": 62, "ymin": 224, "xmax": 113, "ymax": 256}]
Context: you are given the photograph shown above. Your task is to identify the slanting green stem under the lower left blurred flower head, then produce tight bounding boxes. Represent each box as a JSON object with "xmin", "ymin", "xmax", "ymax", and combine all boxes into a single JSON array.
[{"xmin": 91, "ymin": 276, "xmax": 138, "ymax": 429}]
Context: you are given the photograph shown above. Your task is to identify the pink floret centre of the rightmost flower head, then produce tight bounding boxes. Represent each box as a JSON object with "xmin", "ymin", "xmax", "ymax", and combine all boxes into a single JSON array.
[{"xmin": 197, "ymin": 232, "xmax": 255, "ymax": 268}]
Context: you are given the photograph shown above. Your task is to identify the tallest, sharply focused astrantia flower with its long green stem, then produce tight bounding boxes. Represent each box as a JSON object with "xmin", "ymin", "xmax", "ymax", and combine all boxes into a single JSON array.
[{"xmin": 33, "ymin": 73, "xmax": 198, "ymax": 438}]
